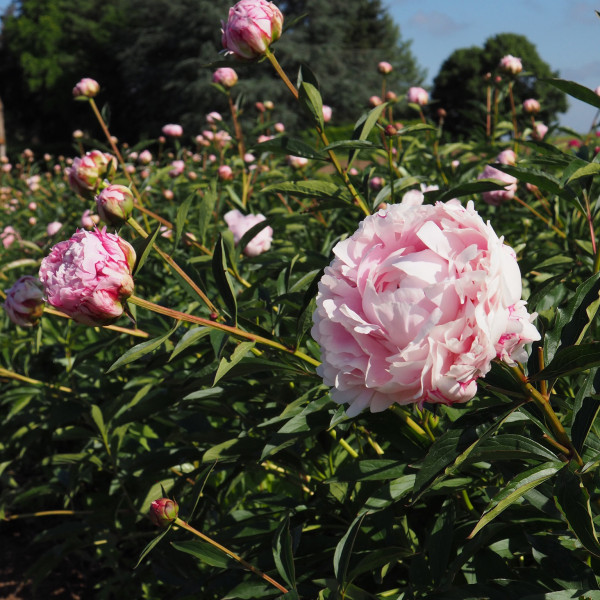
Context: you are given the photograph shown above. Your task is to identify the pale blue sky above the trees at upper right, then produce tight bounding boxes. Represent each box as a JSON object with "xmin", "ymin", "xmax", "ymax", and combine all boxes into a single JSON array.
[{"xmin": 383, "ymin": 0, "xmax": 600, "ymax": 131}]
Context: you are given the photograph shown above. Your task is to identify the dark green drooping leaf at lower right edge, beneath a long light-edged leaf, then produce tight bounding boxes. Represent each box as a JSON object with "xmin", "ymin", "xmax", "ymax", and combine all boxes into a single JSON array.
[{"xmin": 554, "ymin": 469, "xmax": 600, "ymax": 557}]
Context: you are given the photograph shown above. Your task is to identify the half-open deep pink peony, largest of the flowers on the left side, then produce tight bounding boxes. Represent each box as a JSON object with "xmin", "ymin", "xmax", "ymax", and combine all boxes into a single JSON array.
[{"xmin": 40, "ymin": 229, "xmax": 135, "ymax": 325}]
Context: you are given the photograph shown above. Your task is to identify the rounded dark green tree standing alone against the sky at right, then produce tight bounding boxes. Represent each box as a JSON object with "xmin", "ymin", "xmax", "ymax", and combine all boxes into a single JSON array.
[{"xmin": 431, "ymin": 33, "xmax": 567, "ymax": 137}]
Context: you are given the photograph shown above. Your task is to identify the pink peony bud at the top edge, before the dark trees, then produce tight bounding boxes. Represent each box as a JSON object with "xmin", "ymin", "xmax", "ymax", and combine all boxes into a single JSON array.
[{"xmin": 221, "ymin": 0, "xmax": 283, "ymax": 60}]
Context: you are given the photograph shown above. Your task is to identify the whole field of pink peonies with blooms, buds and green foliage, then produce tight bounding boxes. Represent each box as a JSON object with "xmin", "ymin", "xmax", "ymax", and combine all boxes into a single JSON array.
[{"xmin": 0, "ymin": 0, "xmax": 600, "ymax": 600}]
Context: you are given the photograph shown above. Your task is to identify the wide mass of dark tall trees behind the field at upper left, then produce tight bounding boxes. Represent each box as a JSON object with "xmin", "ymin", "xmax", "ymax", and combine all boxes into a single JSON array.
[{"xmin": 0, "ymin": 0, "xmax": 424, "ymax": 152}]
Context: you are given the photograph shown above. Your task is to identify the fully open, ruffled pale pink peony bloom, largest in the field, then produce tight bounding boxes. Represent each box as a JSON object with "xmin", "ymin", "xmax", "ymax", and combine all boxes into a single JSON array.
[{"xmin": 312, "ymin": 200, "xmax": 539, "ymax": 416}]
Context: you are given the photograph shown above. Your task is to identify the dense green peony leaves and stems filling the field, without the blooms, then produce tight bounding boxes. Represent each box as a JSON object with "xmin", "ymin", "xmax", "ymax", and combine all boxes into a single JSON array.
[{"xmin": 0, "ymin": 8, "xmax": 600, "ymax": 600}]
